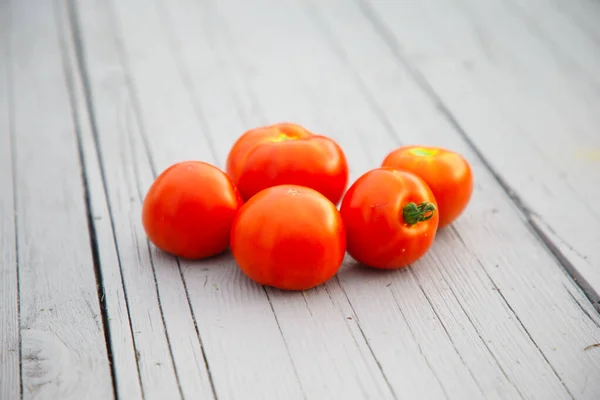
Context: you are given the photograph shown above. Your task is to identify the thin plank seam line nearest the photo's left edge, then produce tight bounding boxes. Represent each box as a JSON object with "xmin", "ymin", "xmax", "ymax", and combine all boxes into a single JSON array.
[{"xmin": 4, "ymin": 2, "xmax": 23, "ymax": 400}]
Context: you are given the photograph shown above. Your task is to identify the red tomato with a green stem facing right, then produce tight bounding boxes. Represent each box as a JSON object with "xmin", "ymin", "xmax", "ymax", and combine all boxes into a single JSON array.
[{"xmin": 340, "ymin": 168, "xmax": 438, "ymax": 269}]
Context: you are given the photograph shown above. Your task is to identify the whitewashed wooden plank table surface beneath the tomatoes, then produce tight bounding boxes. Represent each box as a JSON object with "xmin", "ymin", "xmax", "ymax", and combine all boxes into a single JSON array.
[{"xmin": 0, "ymin": 0, "xmax": 600, "ymax": 400}]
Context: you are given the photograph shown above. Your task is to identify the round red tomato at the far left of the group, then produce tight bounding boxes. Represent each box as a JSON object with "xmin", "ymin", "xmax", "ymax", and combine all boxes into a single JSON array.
[{"xmin": 142, "ymin": 161, "xmax": 243, "ymax": 259}]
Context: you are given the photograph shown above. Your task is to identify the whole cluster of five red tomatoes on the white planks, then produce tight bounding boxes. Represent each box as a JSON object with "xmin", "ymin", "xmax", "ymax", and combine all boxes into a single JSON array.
[{"xmin": 142, "ymin": 123, "xmax": 473, "ymax": 290}]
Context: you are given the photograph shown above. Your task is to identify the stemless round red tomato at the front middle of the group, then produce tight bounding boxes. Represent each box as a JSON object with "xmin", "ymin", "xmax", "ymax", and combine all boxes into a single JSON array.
[{"xmin": 231, "ymin": 185, "xmax": 346, "ymax": 290}]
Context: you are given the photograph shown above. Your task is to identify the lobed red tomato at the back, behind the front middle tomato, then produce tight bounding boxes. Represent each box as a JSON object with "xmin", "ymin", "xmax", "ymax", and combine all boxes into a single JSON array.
[{"xmin": 227, "ymin": 123, "xmax": 348, "ymax": 204}]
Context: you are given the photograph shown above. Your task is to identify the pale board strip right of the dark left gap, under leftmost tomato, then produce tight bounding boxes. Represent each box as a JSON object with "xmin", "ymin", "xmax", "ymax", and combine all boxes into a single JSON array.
[{"xmin": 66, "ymin": 1, "xmax": 212, "ymax": 399}]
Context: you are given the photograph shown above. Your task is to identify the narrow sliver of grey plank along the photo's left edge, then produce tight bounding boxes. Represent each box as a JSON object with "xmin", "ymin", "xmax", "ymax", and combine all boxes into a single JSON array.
[{"xmin": 0, "ymin": 2, "xmax": 21, "ymax": 399}]
